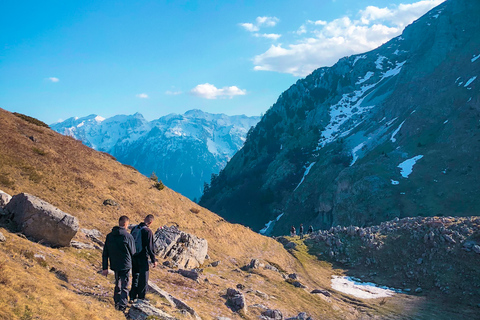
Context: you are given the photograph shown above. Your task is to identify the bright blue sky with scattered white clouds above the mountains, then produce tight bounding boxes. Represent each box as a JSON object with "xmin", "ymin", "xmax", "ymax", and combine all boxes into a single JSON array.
[{"xmin": 0, "ymin": 0, "xmax": 443, "ymax": 124}]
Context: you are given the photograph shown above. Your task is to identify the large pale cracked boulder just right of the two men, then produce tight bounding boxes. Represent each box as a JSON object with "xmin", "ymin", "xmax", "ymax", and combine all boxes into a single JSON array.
[{"xmin": 154, "ymin": 226, "xmax": 208, "ymax": 269}]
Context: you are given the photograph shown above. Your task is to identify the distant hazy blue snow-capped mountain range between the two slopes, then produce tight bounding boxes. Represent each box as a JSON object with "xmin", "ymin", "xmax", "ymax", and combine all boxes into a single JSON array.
[{"xmin": 50, "ymin": 110, "xmax": 260, "ymax": 199}]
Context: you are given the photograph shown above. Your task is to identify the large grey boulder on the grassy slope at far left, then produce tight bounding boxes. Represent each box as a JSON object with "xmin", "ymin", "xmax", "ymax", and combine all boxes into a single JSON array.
[{"xmin": 5, "ymin": 193, "xmax": 78, "ymax": 247}]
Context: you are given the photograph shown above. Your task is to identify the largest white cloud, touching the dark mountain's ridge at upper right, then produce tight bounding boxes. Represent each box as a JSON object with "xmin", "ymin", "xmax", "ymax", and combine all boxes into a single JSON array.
[{"xmin": 253, "ymin": 0, "xmax": 444, "ymax": 76}]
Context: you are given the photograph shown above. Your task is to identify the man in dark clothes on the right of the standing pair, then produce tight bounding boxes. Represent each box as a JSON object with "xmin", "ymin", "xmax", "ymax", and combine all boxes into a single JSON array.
[{"xmin": 130, "ymin": 214, "xmax": 157, "ymax": 302}]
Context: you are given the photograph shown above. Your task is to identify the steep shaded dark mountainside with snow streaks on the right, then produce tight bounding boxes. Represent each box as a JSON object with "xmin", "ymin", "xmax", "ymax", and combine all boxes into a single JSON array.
[{"xmin": 200, "ymin": 0, "xmax": 480, "ymax": 235}]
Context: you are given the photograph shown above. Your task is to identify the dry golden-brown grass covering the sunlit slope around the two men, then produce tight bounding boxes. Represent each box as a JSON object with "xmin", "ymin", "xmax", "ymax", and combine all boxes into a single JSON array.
[{"xmin": 0, "ymin": 109, "xmax": 424, "ymax": 320}]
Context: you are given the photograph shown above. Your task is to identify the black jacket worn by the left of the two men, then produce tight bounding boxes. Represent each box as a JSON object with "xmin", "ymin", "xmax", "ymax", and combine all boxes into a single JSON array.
[{"xmin": 102, "ymin": 227, "xmax": 135, "ymax": 271}]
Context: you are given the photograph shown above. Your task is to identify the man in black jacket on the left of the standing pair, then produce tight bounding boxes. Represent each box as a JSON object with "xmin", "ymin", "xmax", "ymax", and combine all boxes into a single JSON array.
[{"xmin": 102, "ymin": 216, "xmax": 135, "ymax": 311}]
